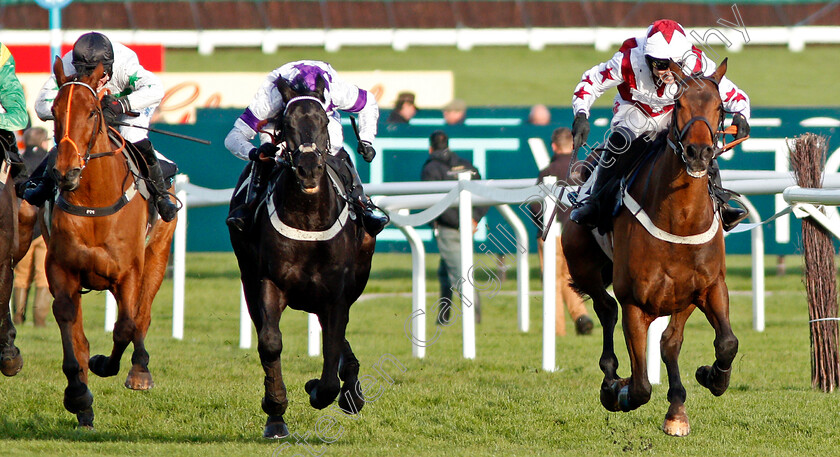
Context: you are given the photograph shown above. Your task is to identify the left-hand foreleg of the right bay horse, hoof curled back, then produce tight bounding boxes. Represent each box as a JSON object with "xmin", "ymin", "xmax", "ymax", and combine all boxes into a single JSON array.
[{"xmin": 601, "ymin": 303, "xmax": 653, "ymax": 412}]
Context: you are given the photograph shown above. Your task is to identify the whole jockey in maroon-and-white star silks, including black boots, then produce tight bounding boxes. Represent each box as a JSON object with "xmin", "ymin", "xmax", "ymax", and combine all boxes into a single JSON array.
[{"xmin": 571, "ymin": 19, "xmax": 750, "ymax": 230}]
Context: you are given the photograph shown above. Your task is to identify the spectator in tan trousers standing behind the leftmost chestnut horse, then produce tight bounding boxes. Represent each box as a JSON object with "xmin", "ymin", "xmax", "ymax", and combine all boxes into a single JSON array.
[{"xmin": 12, "ymin": 127, "xmax": 52, "ymax": 327}]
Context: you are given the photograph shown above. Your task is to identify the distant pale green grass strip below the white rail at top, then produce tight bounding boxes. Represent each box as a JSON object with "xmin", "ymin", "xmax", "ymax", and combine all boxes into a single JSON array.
[{"xmin": 166, "ymin": 46, "xmax": 840, "ymax": 108}]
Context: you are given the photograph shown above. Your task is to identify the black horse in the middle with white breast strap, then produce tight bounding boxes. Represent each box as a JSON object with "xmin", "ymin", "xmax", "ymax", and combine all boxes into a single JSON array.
[{"xmin": 230, "ymin": 76, "xmax": 376, "ymax": 438}]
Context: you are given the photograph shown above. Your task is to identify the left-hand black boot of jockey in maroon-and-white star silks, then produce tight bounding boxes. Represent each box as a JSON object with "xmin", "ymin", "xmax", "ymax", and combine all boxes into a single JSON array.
[{"xmin": 569, "ymin": 130, "xmax": 630, "ymax": 228}]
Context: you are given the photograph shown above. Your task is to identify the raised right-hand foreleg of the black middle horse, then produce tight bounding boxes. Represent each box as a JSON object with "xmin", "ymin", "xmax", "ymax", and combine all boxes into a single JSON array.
[{"xmin": 305, "ymin": 303, "xmax": 349, "ymax": 409}]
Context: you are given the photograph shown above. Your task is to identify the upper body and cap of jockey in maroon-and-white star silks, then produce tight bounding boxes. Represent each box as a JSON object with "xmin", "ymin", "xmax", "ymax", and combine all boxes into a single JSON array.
[{"xmin": 572, "ymin": 20, "xmax": 750, "ymax": 137}]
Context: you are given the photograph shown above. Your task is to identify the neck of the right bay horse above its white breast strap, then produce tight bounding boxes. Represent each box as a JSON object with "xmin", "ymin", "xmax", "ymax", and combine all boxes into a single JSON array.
[{"xmin": 633, "ymin": 148, "xmax": 714, "ymax": 228}]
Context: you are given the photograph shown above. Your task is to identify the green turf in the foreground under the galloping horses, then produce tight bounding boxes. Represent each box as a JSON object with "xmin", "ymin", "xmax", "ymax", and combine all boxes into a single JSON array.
[{"xmin": 0, "ymin": 254, "xmax": 840, "ymax": 457}]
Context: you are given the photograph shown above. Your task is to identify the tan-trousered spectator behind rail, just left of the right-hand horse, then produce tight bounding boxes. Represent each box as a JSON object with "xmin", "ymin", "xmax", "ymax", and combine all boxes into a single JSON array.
[{"xmin": 530, "ymin": 127, "xmax": 593, "ymax": 335}]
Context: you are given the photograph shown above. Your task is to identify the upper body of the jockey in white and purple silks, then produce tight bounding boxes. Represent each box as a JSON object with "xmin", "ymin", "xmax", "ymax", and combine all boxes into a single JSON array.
[{"xmin": 225, "ymin": 60, "xmax": 379, "ymax": 160}]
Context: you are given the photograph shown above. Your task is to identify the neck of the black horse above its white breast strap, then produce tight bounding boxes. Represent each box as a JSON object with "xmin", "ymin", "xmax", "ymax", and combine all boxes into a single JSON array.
[{"xmin": 272, "ymin": 170, "xmax": 338, "ymax": 231}]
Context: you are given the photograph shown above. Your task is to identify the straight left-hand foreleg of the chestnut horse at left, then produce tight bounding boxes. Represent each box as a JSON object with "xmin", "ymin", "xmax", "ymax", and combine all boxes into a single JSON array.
[{"xmin": 48, "ymin": 272, "xmax": 93, "ymax": 428}]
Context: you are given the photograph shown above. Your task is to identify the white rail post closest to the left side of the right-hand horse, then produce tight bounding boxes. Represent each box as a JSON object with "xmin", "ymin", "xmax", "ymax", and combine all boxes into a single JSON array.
[{"xmin": 543, "ymin": 176, "xmax": 558, "ymax": 372}]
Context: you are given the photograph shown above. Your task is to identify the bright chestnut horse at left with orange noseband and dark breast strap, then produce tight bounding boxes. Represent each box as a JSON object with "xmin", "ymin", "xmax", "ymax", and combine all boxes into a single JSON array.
[{"xmin": 45, "ymin": 58, "xmax": 176, "ymax": 428}]
